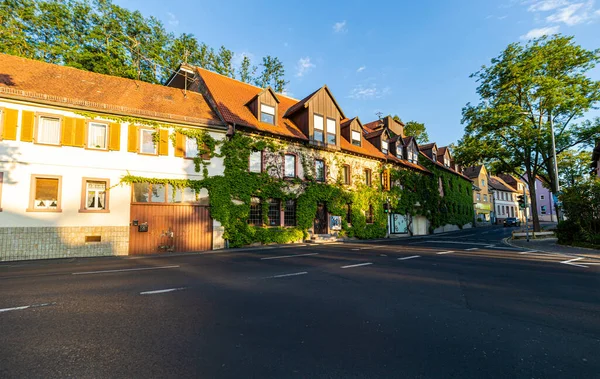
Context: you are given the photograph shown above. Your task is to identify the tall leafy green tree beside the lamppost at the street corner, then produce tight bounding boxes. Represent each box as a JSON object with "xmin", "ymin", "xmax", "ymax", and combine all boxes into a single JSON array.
[{"xmin": 455, "ymin": 35, "xmax": 600, "ymax": 231}]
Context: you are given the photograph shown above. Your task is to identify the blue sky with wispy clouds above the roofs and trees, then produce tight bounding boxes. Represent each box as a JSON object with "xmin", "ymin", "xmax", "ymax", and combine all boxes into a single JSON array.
[{"xmin": 115, "ymin": 0, "xmax": 600, "ymax": 146}]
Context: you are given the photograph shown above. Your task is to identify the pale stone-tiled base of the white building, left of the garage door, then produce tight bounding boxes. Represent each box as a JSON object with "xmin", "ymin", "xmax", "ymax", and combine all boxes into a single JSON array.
[{"xmin": 0, "ymin": 226, "xmax": 129, "ymax": 262}]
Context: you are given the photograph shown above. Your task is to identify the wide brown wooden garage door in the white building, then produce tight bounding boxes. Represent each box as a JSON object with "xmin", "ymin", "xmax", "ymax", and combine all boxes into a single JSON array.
[{"xmin": 129, "ymin": 204, "xmax": 212, "ymax": 255}]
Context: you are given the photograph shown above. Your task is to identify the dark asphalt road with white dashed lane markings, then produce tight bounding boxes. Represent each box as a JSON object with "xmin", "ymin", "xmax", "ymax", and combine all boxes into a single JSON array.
[{"xmin": 0, "ymin": 227, "xmax": 600, "ymax": 379}]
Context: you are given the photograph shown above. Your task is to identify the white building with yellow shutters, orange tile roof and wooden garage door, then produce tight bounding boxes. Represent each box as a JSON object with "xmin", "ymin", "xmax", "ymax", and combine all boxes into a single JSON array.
[{"xmin": 0, "ymin": 54, "xmax": 226, "ymax": 261}]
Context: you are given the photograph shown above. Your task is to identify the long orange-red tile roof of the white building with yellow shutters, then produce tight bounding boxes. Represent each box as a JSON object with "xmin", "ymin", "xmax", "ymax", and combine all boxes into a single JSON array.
[{"xmin": 0, "ymin": 54, "xmax": 223, "ymax": 125}]
